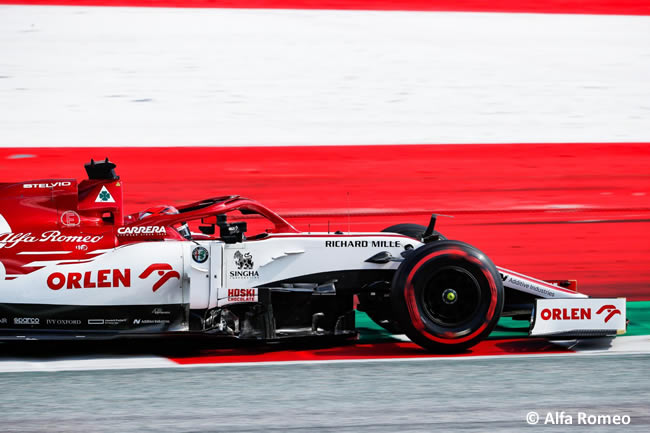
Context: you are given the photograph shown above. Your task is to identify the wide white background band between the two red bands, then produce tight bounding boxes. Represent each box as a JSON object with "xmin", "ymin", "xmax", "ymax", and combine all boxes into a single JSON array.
[{"xmin": 0, "ymin": 6, "xmax": 650, "ymax": 146}]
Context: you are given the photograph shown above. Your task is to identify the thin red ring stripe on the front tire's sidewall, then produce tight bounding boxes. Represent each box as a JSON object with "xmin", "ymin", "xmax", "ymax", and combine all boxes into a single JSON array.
[{"xmin": 404, "ymin": 248, "xmax": 498, "ymax": 344}]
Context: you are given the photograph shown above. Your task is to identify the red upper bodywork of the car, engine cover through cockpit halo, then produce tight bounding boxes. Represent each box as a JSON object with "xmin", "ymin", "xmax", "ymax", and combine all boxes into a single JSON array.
[{"xmin": 0, "ymin": 172, "xmax": 299, "ymax": 274}]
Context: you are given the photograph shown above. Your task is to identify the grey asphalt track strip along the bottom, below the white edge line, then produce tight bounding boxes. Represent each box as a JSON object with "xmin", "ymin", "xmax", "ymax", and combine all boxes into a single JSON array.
[{"xmin": 0, "ymin": 355, "xmax": 650, "ymax": 433}]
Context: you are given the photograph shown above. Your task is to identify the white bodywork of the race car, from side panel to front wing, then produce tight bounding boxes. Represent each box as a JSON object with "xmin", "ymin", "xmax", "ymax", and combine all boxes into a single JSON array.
[{"xmin": 0, "ymin": 226, "xmax": 625, "ymax": 336}]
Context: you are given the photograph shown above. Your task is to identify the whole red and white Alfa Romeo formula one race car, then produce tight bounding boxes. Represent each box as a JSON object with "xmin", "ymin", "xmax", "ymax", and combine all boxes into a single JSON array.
[{"xmin": 0, "ymin": 159, "xmax": 625, "ymax": 352}]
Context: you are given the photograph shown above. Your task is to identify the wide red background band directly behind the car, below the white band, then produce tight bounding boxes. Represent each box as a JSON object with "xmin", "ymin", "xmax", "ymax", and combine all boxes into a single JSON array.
[{"xmin": 0, "ymin": 143, "xmax": 650, "ymax": 299}]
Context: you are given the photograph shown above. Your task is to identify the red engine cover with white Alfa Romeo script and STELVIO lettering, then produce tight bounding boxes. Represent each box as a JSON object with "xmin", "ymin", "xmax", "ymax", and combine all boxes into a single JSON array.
[{"xmin": 0, "ymin": 179, "xmax": 123, "ymax": 278}]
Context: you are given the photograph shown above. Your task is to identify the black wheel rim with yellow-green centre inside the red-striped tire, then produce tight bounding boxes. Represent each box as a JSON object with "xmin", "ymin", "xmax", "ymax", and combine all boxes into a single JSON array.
[{"xmin": 421, "ymin": 266, "xmax": 481, "ymax": 328}]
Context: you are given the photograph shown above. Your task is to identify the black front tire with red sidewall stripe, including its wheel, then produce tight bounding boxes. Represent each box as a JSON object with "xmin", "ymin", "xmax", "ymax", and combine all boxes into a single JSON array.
[{"xmin": 391, "ymin": 240, "xmax": 504, "ymax": 353}]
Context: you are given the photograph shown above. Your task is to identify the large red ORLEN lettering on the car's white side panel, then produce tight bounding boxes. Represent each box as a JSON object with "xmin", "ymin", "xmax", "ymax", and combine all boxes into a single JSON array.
[{"xmin": 47, "ymin": 269, "xmax": 131, "ymax": 290}]
